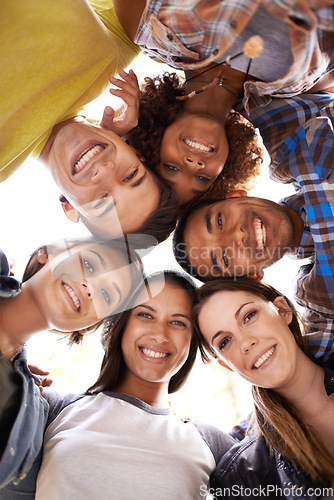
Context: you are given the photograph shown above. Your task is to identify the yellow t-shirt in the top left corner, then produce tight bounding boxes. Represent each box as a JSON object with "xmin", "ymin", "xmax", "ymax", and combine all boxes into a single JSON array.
[{"xmin": 0, "ymin": 0, "xmax": 139, "ymax": 182}]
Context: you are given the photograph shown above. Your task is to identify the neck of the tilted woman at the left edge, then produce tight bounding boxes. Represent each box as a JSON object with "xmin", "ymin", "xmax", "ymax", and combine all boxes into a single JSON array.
[{"xmin": 0, "ymin": 284, "xmax": 49, "ymax": 361}]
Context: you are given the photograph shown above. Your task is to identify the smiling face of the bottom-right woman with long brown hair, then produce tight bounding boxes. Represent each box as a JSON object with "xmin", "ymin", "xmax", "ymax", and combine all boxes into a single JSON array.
[{"xmin": 198, "ymin": 291, "xmax": 302, "ymax": 390}]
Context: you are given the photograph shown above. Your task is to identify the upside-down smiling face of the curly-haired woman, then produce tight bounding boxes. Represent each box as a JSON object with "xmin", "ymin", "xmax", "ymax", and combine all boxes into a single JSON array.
[{"xmin": 157, "ymin": 112, "xmax": 229, "ymax": 205}]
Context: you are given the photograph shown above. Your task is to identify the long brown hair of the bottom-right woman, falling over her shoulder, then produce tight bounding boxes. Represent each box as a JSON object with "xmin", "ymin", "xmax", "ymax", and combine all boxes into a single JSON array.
[{"xmin": 193, "ymin": 278, "xmax": 334, "ymax": 484}]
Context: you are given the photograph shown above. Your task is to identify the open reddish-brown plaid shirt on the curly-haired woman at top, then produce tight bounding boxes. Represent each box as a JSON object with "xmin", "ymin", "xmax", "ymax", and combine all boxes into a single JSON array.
[{"xmin": 135, "ymin": 0, "xmax": 334, "ymax": 107}]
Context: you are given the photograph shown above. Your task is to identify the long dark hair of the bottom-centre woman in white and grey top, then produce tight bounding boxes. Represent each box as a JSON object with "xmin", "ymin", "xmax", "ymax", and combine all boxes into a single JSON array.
[{"xmin": 87, "ymin": 271, "xmax": 197, "ymax": 394}]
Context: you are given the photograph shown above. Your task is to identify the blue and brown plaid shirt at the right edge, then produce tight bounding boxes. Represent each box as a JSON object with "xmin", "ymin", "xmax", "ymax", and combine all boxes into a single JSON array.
[{"xmin": 240, "ymin": 92, "xmax": 334, "ymax": 360}]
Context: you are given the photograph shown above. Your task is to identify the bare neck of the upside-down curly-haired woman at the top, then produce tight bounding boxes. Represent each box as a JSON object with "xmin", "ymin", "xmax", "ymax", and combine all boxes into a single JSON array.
[{"xmin": 184, "ymin": 64, "xmax": 245, "ymax": 125}]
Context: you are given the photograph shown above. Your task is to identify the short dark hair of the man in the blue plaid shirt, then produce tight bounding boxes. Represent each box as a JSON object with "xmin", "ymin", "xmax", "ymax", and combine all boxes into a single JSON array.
[{"xmin": 173, "ymin": 198, "xmax": 226, "ymax": 281}]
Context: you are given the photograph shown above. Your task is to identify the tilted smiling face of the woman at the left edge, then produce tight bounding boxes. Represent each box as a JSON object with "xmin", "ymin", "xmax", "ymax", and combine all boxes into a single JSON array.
[{"xmin": 22, "ymin": 244, "xmax": 131, "ymax": 332}]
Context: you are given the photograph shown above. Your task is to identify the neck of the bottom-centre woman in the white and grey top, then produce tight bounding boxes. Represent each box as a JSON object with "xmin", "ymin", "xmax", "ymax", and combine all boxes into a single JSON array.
[{"xmin": 114, "ymin": 372, "xmax": 169, "ymax": 408}]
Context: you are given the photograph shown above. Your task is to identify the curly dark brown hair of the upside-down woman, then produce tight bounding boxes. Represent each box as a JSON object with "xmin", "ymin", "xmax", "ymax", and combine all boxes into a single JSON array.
[{"xmin": 128, "ymin": 73, "xmax": 263, "ymax": 201}]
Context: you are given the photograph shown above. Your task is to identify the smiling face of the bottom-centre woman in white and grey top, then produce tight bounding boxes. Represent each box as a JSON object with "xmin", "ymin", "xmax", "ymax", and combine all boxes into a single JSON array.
[{"xmin": 122, "ymin": 283, "xmax": 192, "ymax": 387}]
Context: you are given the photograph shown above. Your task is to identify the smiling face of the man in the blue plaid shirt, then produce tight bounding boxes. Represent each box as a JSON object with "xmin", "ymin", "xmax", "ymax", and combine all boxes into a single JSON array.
[{"xmin": 184, "ymin": 197, "xmax": 294, "ymax": 278}]
